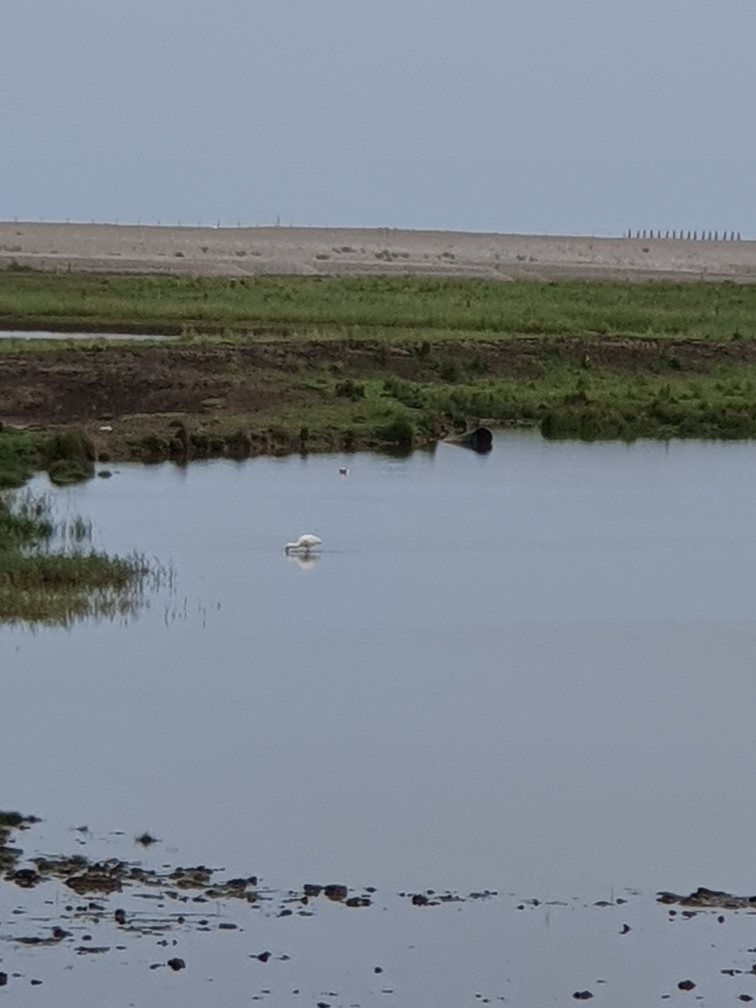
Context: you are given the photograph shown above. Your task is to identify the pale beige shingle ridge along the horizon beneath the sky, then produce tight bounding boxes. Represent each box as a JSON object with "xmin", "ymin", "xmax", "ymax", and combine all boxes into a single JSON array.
[{"xmin": 0, "ymin": 222, "xmax": 756, "ymax": 283}]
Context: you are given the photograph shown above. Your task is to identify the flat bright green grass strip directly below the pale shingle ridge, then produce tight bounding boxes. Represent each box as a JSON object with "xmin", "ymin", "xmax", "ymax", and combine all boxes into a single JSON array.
[{"xmin": 0, "ymin": 269, "xmax": 756, "ymax": 343}]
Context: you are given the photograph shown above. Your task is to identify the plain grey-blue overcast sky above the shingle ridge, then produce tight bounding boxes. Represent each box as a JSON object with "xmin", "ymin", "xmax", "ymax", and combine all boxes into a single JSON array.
[{"xmin": 0, "ymin": 0, "xmax": 756, "ymax": 237}]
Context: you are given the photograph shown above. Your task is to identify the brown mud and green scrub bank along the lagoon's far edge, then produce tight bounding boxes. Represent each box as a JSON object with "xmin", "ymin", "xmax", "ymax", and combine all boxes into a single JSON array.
[{"xmin": 0, "ymin": 338, "xmax": 756, "ymax": 461}]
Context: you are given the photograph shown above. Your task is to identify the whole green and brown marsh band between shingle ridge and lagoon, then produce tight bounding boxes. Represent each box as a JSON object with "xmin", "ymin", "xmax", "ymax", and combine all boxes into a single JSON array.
[{"xmin": 0, "ymin": 272, "xmax": 756, "ymax": 453}]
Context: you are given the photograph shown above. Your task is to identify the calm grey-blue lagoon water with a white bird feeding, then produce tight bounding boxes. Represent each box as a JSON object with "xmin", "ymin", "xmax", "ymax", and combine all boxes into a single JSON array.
[{"xmin": 0, "ymin": 433, "xmax": 756, "ymax": 1006}]
